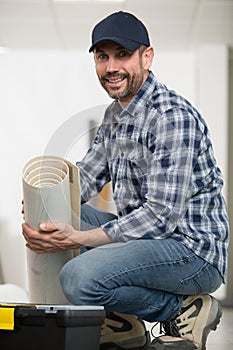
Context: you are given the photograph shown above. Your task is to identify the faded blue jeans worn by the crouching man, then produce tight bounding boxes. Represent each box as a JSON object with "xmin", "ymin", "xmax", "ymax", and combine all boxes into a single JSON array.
[{"xmin": 60, "ymin": 205, "xmax": 222, "ymax": 322}]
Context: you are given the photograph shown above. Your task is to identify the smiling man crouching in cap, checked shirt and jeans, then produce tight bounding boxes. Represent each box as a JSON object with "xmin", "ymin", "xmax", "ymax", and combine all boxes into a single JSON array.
[{"xmin": 23, "ymin": 12, "xmax": 228, "ymax": 350}]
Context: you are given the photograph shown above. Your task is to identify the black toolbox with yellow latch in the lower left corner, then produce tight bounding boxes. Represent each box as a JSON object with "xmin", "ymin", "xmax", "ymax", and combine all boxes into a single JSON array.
[{"xmin": 0, "ymin": 304, "xmax": 105, "ymax": 350}]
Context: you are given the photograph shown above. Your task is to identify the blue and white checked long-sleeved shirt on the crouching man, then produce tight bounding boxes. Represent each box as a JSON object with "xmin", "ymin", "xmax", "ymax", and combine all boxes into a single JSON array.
[{"xmin": 77, "ymin": 72, "xmax": 228, "ymax": 278}]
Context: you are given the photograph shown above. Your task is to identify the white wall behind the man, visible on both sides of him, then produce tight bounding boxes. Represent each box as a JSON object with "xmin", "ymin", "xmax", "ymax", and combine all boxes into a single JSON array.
[{"xmin": 0, "ymin": 47, "xmax": 227, "ymax": 294}]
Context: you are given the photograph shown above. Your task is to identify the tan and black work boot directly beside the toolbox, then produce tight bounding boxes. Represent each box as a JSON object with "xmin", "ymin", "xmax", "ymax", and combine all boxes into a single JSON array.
[{"xmin": 100, "ymin": 312, "xmax": 150, "ymax": 350}]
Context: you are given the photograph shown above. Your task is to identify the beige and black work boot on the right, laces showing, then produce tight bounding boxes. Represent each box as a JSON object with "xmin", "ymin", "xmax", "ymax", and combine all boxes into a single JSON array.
[{"xmin": 149, "ymin": 294, "xmax": 222, "ymax": 350}]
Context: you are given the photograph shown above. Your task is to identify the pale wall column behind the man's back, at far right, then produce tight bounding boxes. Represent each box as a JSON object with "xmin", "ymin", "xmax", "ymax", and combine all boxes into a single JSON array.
[{"xmin": 196, "ymin": 45, "xmax": 229, "ymax": 196}]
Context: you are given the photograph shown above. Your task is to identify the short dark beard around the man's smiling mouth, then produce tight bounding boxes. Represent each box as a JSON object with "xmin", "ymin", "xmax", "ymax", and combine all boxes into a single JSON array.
[{"xmin": 99, "ymin": 71, "xmax": 143, "ymax": 102}]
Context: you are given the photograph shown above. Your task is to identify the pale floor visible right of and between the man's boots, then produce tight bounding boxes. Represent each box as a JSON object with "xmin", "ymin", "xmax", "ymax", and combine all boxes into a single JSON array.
[{"xmin": 147, "ymin": 308, "xmax": 233, "ymax": 350}]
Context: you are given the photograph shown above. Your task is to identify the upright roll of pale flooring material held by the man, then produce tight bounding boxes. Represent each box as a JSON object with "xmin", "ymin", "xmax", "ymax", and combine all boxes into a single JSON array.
[{"xmin": 23, "ymin": 155, "xmax": 80, "ymax": 304}]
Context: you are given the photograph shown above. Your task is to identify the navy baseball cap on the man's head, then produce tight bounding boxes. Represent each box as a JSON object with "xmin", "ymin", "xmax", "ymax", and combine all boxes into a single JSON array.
[{"xmin": 89, "ymin": 11, "xmax": 150, "ymax": 52}]
